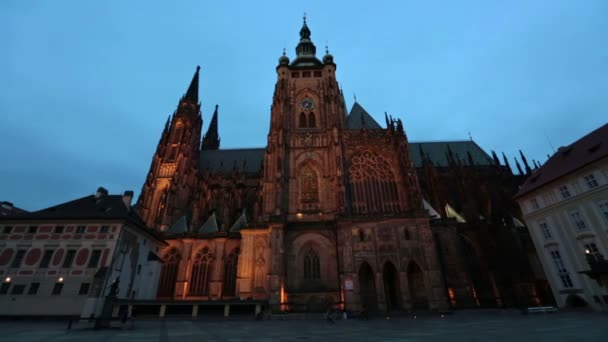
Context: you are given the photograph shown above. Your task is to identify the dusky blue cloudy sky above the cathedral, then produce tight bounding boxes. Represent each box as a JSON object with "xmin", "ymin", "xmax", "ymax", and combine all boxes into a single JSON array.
[{"xmin": 0, "ymin": 0, "xmax": 608, "ymax": 210}]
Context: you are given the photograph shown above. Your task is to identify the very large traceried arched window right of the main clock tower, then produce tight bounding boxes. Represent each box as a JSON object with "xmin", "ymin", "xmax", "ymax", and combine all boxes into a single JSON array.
[{"xmin": 349, "ymin": 152, "xmax": 400, "ymax": 214}]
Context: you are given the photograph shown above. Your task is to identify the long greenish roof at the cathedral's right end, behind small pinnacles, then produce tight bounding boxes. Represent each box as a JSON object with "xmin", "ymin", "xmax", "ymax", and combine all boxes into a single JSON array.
[{"xmin": 409, "ymin": 140, "xmax": 493, "ymax": 167}]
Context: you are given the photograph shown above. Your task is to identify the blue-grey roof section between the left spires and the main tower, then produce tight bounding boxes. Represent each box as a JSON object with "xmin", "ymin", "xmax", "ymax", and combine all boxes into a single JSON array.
[{"xmin": 199, "ymin": 147, "xmax": 266, "ymax": 173}]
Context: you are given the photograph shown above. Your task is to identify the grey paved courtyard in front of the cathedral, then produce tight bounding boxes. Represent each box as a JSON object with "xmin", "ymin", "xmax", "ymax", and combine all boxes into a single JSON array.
[{"xmin": 0, "ymin": 311, "xmax": 608, "ymax": 342}]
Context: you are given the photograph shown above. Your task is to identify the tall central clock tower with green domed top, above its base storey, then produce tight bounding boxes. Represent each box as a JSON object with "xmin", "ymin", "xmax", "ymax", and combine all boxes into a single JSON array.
[{"xmin": 262, "ymin": 18, "xmax": 346, "ymax": 222}]
